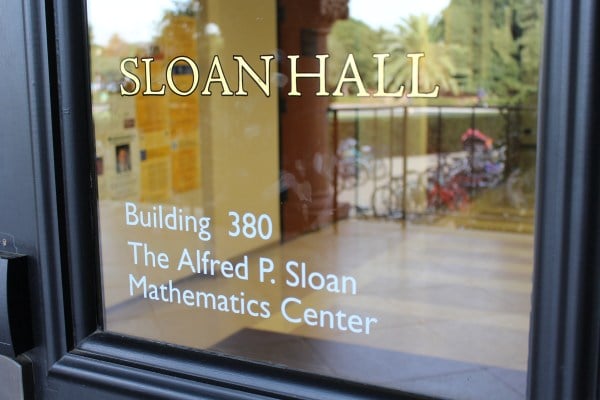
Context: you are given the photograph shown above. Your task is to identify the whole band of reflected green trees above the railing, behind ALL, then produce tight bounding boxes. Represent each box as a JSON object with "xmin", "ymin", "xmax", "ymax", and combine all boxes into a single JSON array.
[{"xmin": 328, "ymin": 0, "xmax": 543, "ymax": 104}]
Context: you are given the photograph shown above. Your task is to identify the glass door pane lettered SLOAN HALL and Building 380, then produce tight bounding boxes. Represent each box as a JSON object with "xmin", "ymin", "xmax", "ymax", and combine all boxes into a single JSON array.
[{"xmin": 88, "ymin": 0, "xmax": 543, "ymax": 400}]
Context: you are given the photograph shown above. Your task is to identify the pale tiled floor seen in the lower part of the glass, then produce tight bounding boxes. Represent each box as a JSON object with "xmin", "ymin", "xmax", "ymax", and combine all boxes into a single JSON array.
[{"xmin": 103, "ymin": 219, "xmax": 533, "ymax": 400}]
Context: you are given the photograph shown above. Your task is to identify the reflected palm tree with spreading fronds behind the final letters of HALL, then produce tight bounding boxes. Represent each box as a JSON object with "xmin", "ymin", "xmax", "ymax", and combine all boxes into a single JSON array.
[{"xmin": 383, "ymin": 15, "xmax": 458, "ymax": 94}]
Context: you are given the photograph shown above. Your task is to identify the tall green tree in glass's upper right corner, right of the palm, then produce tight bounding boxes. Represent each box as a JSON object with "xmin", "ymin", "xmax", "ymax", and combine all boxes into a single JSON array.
[{"xmin": 443, "ymin": 0, "xmax": 542, "ymax": 104}]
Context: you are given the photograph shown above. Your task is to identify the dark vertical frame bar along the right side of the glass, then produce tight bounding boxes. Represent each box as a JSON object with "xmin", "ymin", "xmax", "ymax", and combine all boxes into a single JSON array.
[{"xmin": 528, "ymin": 0, "xmax": 600, "ymax": 400}]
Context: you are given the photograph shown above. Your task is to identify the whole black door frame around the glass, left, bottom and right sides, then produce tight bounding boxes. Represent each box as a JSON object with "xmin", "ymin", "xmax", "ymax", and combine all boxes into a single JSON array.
[{"xmin": 0, "ymin": 0, "xmax": 600, "ymax": 400}]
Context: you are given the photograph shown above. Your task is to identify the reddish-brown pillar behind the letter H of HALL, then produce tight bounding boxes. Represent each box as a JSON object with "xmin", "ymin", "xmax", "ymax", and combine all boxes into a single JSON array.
[{"xmin": 278, "ymin": 0, "xmax": 348, "ymax": 240}]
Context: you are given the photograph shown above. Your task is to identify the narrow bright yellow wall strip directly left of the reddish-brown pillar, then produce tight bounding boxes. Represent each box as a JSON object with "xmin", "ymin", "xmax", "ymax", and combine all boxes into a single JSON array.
[{"xmin": 200, "ymin": 0, "xmax": 280, "ymax": 258}]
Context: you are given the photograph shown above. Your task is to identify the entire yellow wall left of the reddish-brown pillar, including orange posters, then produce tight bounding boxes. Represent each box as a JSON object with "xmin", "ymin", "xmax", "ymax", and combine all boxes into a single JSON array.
[{"xmin": 95, "ymin": 0, "xmax": 280, "ymax": 310}]
